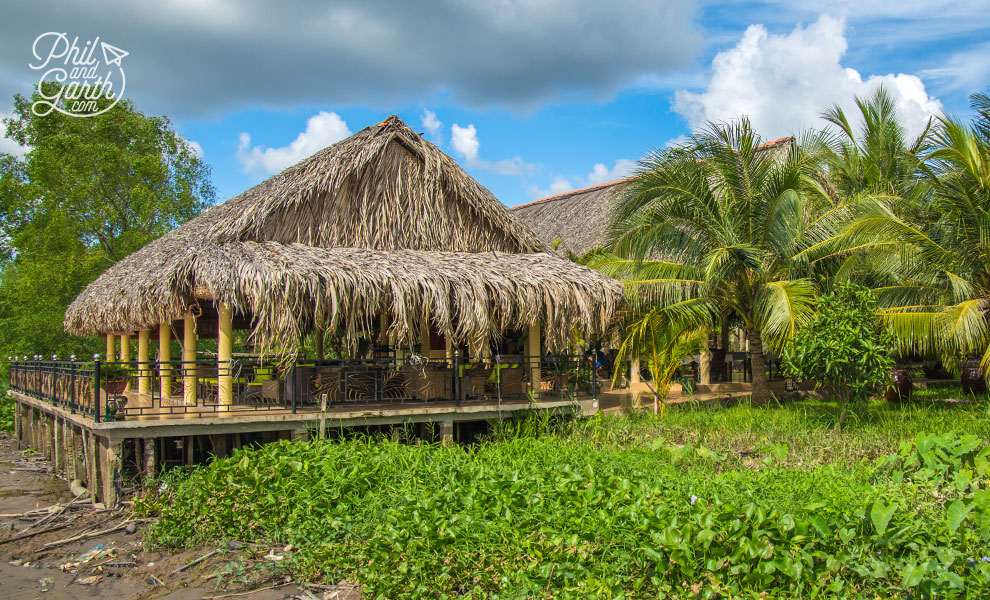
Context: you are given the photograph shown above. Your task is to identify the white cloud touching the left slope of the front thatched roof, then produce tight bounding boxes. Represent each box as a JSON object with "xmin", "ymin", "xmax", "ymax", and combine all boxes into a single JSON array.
[{"xmin": 237, "ymin": 111, "xmax": 351, "ymax": 174}]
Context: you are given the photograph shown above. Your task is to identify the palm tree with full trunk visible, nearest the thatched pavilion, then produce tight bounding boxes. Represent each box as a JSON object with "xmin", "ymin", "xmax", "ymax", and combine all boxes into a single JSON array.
[{"xmin": 594, "ymin": 119, "xmax": 838, "ymax": 400}]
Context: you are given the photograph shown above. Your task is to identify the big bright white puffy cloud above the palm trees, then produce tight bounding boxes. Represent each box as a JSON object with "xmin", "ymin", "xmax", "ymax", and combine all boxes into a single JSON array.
[{"xmin": 673, "ymin": 15, "xmax": 942, "ymax": 139}]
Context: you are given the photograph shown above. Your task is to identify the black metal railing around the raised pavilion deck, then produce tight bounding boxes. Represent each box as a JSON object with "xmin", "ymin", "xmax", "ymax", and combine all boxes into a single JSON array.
[{"xmin": 10, "ymin": 354, "xmax": 602, "ymax": 422}]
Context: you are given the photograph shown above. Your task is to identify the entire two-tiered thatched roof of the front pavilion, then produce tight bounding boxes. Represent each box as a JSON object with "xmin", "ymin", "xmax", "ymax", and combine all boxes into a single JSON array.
[{"xmin": 64, "ymin": 116, "xmax": 623, "ymax": 351}]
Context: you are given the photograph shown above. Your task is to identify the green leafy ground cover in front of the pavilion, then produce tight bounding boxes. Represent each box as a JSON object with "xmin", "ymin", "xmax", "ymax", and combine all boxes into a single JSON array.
[{"xmin": 139, "ymin": 402, "xmax": 990, "ymax": 598}]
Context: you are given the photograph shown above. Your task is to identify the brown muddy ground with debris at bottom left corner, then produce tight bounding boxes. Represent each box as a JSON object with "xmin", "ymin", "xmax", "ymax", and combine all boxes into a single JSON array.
[{"xmin": 0, "ymin": 434, "xmax": 360, "ymax": 600}]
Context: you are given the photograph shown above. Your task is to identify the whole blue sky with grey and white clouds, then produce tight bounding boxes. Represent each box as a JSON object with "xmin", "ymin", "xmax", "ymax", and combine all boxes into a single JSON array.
[{"xmin": 0, "ymin": 0, "xmax": 990, "ymax": 206}]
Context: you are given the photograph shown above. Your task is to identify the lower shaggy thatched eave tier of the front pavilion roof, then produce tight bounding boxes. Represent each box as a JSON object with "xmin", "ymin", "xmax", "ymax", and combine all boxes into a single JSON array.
[{"xmin": 65, "ymin": 242, "xmax": 624, "ymax": 351}]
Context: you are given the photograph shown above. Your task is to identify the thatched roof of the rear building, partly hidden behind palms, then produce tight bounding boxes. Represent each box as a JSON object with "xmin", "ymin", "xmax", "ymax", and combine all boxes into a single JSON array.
[{"xmin": 509, "ymin": 137, "xmax": 794, "ymax": 256}]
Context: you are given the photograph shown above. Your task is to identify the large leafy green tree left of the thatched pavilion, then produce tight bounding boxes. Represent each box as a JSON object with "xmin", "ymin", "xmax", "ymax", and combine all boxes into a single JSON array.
[{"xmin": 0, "ymin": 84, "xmax": 215, "ymax": 366}]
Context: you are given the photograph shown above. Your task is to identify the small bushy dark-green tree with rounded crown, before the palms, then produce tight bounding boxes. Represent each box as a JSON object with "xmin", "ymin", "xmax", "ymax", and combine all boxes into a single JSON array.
[{"xmin": 784, "ymin": 282, "xmax": 894, "ymax": 431}]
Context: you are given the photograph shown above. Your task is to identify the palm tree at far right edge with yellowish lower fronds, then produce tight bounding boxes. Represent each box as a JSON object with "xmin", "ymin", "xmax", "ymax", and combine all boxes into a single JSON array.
[{"xmin": 843, "ymin": 94, "xmax": 990, "ymax": 369}]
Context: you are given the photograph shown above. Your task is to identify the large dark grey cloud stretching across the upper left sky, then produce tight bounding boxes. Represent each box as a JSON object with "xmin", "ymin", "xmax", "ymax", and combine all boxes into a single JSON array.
[{"xmin": 0, "ymin": 0, "xmax": 702, "ymax": 118}]
